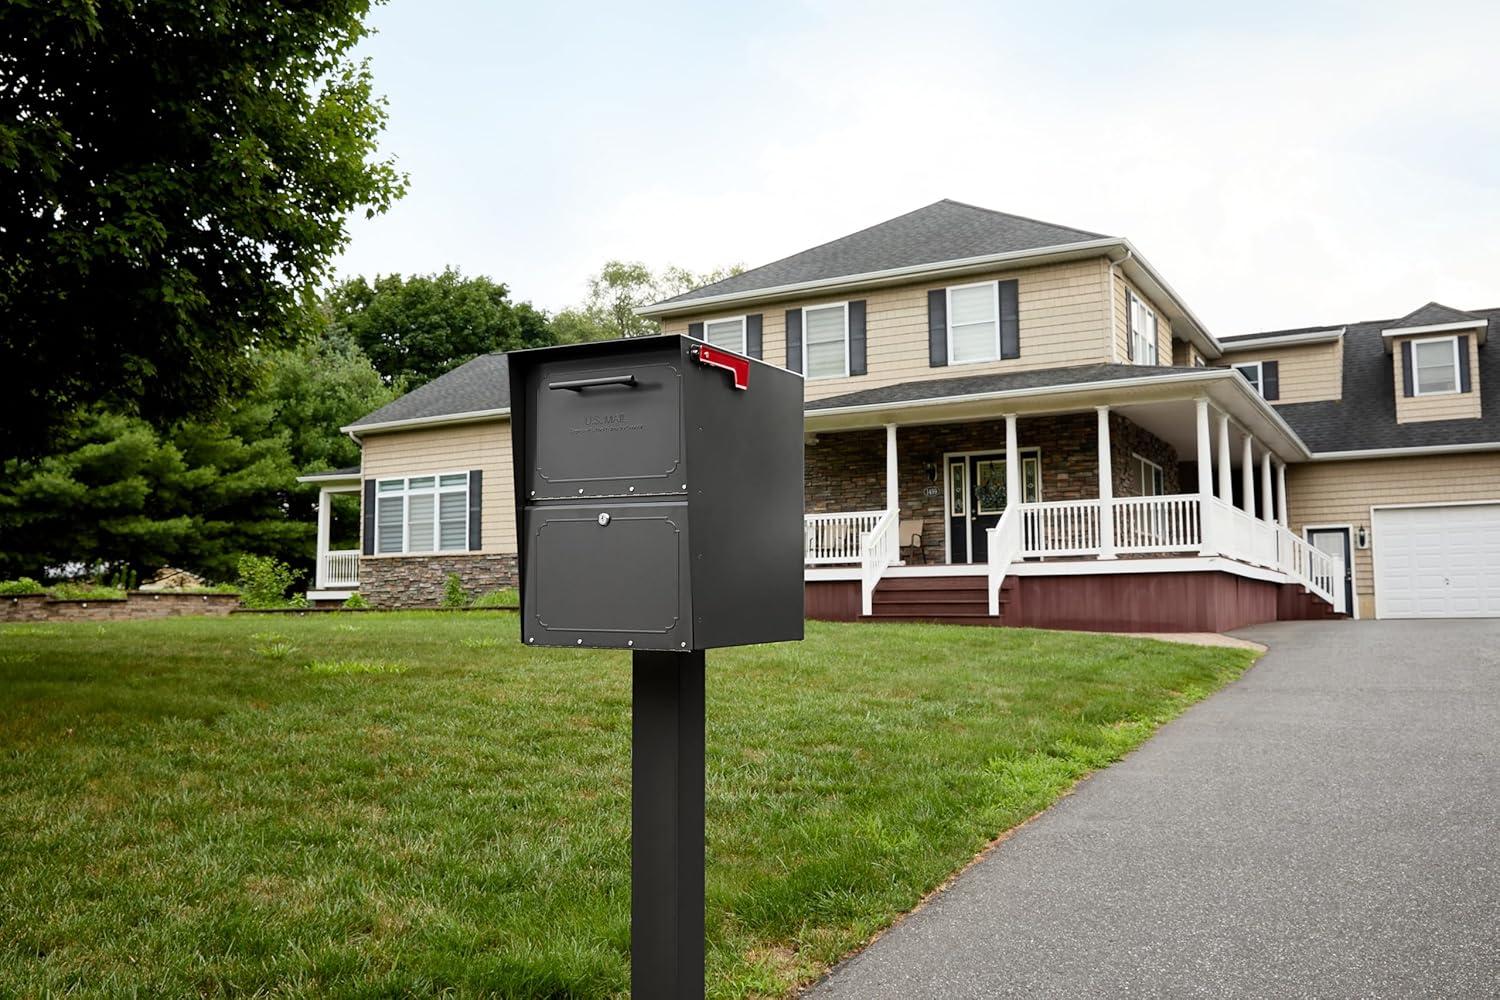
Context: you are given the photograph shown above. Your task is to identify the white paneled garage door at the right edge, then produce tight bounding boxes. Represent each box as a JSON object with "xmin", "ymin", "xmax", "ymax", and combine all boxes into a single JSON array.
[{"xmin": 1373, "ymin": 504, "xmax": 1500, "ymax": 618}]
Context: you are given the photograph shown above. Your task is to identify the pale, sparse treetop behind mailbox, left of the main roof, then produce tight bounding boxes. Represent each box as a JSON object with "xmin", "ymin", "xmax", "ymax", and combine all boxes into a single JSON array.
[{"xmin": 552, "ymin": 261, "xmax": 744, "ymax": 343}]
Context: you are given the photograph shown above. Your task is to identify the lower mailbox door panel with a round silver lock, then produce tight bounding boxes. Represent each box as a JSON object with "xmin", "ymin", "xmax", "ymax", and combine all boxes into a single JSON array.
[{"xmin": 522, "ymin": 502, "xmax": 693, "ymax": 649}]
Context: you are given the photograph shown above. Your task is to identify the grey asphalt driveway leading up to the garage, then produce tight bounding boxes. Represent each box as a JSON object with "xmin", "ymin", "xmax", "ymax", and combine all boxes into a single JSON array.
[{"xmin": 807, "ymin": 621, "xmax": 1500, "ymax": 1000}]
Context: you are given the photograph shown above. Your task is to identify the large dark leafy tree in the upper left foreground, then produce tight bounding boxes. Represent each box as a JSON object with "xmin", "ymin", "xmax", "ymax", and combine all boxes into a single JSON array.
[{"xmin": 0, "ymin": 0, "xmax": 405, "ymax": 457}]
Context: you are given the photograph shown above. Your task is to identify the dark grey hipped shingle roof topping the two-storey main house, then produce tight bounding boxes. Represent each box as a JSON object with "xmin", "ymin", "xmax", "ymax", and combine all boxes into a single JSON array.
[{"xmin": 659, "ymin": 198, "xmax": 1109, "ymax": 304}]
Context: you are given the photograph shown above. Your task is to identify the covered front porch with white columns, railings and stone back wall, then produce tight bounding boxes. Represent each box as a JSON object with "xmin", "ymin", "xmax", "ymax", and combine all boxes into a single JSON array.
[{"xmin": 804, "ymin": 372, "xmax": 1344, "ymax": 616}]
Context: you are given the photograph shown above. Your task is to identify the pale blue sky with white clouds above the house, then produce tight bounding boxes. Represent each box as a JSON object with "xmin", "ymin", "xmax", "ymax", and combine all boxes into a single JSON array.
[{"xmin": 338, "ymin": 0, "xmax": 1500, "ymax": 336}]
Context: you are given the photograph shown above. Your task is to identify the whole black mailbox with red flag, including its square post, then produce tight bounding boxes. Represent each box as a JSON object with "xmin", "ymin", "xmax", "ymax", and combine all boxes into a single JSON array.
[{"xmin": 510, "ymin": 336, "xmax": 803, "ymax": 1000}]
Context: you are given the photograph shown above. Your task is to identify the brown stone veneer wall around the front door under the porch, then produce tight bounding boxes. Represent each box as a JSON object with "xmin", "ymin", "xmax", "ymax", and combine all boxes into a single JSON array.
[{"xmin": 804, "ymin": 412, "xmax": 1181, "ymax": 564}]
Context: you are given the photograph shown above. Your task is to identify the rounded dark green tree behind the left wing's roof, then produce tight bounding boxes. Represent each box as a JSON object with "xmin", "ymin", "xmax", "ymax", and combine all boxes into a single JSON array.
[{"xmin": 327, "ymin": 267, "xmax": 554, "ymax": 390}]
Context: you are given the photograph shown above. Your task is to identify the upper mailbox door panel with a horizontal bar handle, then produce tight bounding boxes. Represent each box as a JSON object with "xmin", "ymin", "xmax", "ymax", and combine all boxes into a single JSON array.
[{"xmin": 527, "ymin": 354, "xmax": 686, "ymax": 499}]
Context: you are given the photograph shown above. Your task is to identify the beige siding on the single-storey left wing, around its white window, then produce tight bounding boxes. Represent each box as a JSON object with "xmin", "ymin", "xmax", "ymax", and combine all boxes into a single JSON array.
[{"xmin": 363, "ymin": 420, "xmax": 516, "ymax": 552}]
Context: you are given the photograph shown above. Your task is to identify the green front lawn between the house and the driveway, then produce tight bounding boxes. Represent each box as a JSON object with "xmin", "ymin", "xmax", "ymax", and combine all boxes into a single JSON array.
[{"xmin": 0, "ymin": 612, "xmax": 1251, "ymax": 997}]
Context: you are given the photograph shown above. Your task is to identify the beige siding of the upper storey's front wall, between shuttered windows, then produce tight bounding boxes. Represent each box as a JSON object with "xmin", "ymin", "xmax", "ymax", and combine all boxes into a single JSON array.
[{"xmin": 662, "ymin": 258, "xmax": 1122, "ymax": 399}]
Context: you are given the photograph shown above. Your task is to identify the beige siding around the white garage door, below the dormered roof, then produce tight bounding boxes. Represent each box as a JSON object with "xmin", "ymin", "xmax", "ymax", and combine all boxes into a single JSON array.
[{"xmin": 1287, "ymin": 453, "xmax": 1500, "ymax": 618}]
